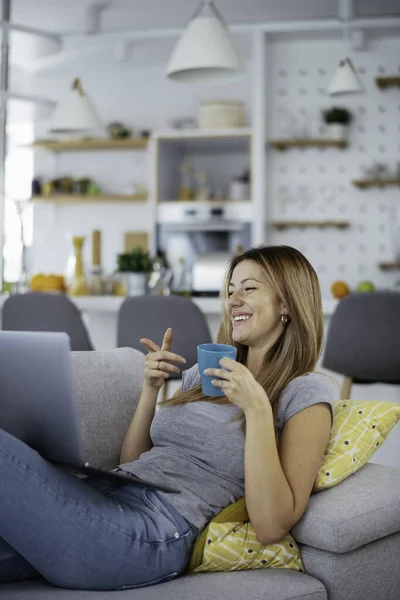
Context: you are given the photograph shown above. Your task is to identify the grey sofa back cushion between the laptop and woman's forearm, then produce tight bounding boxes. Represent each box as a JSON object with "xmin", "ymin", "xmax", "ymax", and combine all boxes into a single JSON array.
[{"xmin": 71, "ymin": 348, "xmax": 144, "ymax": 469}]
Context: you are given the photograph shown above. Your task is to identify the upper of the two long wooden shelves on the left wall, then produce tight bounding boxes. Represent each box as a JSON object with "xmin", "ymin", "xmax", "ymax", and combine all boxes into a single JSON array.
[{"xmin": 32, "ymin": 138, "xmax": 149, "ymax": 152}]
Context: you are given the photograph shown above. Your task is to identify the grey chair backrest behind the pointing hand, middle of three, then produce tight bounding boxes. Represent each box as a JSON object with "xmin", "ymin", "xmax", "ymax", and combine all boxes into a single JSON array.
[{"xmin": 117, "ymin": 296, "xmax": 212, "ymax": 369}]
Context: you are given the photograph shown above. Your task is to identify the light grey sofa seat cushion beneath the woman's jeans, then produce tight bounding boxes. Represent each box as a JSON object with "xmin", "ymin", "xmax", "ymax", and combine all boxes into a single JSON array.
[{"xmin": 0, "ymin": 569, "xmax": 327, "ymax": 600}]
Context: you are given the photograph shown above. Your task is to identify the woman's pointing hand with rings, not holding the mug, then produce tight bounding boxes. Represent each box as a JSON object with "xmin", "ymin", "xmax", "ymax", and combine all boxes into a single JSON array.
[{"xmin": 140, "ymin": 329, "xmax": 186, "ymax": 390}]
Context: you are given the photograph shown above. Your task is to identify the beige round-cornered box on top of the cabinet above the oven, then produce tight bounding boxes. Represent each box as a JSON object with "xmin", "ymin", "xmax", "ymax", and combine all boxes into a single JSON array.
[{"xmin": 199, "ymin": 100, "xmax": 245, "ymax": 129}]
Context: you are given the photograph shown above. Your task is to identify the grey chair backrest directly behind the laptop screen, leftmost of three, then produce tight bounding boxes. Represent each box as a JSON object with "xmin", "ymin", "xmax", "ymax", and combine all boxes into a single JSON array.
[{"xmin": 2, "ymin": 292, "xmax": 93, "ymax": 350}]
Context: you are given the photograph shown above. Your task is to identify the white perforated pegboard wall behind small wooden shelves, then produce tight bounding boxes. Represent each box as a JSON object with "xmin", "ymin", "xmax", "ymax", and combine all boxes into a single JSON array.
[{"xmin": 267, "ymin": 40, "xmax": 400, "ymax": 297}]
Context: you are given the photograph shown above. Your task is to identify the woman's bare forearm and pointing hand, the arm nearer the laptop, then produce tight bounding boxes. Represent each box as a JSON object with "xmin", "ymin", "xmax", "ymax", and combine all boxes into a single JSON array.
[{"xmin": 120, "ymin": 329, "xmax": 186, "ymax": 464}]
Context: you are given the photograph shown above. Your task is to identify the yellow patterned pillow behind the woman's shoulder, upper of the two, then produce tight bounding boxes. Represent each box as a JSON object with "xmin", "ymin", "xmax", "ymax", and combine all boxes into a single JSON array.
[{"xmin": 314, "ymin": 400, "xmax": 400, "ymax": 491}]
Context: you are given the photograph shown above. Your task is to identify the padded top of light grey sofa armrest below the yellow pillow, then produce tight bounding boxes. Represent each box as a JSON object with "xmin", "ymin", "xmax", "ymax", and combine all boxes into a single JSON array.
[{"xmin": 292, "ymin": 463, "xmax": 400, "ymax": 553}]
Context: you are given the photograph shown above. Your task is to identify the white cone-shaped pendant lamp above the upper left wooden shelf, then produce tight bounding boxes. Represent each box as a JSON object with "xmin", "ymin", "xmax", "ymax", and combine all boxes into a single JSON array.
[{"xmin": 50, "ymin": 78, "xmax": 104, "ymax": 134}]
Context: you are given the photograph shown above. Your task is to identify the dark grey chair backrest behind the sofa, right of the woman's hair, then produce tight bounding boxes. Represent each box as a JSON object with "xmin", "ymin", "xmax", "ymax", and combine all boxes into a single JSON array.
[{"xmin": 322, "ymin": 291, "xmax": 400, "ymax": 384}]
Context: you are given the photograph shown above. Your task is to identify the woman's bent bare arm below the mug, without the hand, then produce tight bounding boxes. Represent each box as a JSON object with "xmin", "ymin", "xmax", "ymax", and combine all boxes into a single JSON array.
[{"xmin": 245, "ymin": 403, "xmax": 331, "ymax": 544}]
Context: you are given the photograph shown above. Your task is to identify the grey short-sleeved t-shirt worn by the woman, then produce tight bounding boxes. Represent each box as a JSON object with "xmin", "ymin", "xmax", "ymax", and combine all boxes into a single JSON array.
[{"xmin": 120, "ymin": 365, "xmax": 334, "ymax": 530}]
